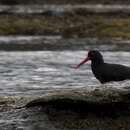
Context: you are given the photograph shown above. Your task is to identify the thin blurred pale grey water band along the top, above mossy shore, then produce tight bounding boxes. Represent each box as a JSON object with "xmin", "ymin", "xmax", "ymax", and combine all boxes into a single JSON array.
[{"xmin": 0, "ymin": 4, "xmax": 130, "ymax": 16}]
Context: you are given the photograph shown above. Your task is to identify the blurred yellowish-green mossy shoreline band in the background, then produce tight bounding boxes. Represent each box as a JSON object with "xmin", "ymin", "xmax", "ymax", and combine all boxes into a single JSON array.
[{"xmin": 0, "ymin": 14, "xmax": 130, "ymax": 39}]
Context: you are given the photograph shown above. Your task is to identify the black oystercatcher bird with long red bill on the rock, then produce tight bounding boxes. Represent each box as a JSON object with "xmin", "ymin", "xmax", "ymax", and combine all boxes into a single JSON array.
[{"xmin": 76, "ymin": 50, "xmax": 130, "ymax": 83}]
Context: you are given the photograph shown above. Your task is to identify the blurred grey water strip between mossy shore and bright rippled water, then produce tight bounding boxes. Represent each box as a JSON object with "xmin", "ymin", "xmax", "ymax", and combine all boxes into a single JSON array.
[{"xmin": 0, "ymin": 35, "xmax": 130, "ymax": 51}]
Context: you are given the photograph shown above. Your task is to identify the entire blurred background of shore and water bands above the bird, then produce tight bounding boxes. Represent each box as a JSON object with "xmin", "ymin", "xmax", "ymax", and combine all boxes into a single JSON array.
[{"xmin": 0, "ymin": 0, "xmax": 130, "ymax": 51}]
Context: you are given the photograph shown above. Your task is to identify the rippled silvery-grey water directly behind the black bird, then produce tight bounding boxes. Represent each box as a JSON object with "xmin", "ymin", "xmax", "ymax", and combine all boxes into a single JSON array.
[{"xmin": 0, "ymin": 51, "xmax": 130, "ymax": 96}]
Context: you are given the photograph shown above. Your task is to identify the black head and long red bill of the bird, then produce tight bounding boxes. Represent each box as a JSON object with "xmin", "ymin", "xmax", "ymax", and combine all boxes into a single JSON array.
[{"xmin": 76, "ymin": 50, "xmax": 104, "ymax": 68}]
